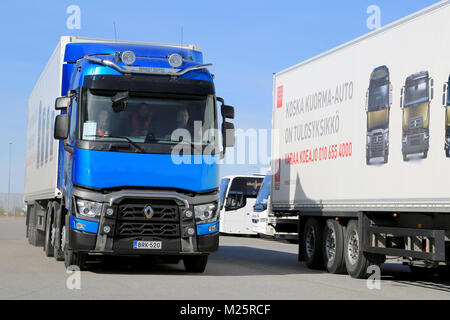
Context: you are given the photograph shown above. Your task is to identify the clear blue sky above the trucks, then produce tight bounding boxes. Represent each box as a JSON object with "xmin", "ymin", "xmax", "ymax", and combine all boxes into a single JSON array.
[{"xmin": 0, "ymin": 0, "xmax": 437, "ymax": 192}]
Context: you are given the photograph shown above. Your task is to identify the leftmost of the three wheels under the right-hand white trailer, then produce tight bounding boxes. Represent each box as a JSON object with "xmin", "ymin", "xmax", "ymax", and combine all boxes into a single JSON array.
[{"xmin": 302, "ymin": 218, "xmax": 323, "ymax": 269}]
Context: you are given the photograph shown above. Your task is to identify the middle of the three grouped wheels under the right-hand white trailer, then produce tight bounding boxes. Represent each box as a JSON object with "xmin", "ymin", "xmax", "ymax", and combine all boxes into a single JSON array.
[{"xmin": 322, "ymin": 219, "xmax": 345, "ymax": 273}]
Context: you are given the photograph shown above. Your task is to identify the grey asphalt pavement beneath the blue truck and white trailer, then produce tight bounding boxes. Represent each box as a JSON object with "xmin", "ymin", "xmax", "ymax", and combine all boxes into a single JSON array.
[{"xmin": 0, "ymin": 217, "xmax": 450, "ymax": 300}]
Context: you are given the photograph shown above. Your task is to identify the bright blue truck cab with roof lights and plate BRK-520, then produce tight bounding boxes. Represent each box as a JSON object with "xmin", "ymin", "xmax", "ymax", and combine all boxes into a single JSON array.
[{"xmin": 44, "ymin": 37, "xmax": 234, "ymax": 272}]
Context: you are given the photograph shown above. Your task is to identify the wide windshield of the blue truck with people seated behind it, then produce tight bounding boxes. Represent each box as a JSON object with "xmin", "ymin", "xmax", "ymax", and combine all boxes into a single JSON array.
[{"xmin": 81, "ymin": 90, "xmax": 215, "ymax": 145}]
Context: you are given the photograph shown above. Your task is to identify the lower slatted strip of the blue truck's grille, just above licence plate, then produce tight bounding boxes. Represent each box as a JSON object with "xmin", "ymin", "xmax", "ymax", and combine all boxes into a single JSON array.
[{"xmin": 118, "ymin": 222, "xmax": 180, "ymax": 237}]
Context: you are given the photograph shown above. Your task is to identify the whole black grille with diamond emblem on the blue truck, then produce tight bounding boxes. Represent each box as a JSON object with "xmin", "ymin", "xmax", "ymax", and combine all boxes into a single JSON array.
[{"xmin": 116, "ymin": 199, "xmax": 180, "ymax": 238}]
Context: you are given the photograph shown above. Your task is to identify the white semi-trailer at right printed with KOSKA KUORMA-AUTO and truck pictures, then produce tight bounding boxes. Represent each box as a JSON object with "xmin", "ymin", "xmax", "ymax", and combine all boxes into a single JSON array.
[{"xmin": 271, "ymin": 1, "xmax": 450, "ymax": 278}]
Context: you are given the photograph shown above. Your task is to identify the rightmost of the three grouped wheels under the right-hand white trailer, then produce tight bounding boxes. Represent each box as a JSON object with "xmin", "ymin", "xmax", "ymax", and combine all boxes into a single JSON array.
[{"xmin": 344, "ymin": 220, "xmax": 384, "ymax": 279}]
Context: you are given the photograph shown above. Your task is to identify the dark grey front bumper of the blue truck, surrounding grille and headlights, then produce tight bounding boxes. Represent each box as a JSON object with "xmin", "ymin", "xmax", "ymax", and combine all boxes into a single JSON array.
[{"xmin": 68, "ymin": 189, "xmax": 219, "ymax": 255}]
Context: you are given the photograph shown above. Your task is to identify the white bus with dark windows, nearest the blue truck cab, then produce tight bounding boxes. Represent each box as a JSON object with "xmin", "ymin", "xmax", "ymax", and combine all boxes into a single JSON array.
[{"xmin": 219, "ymin": 174, "xmax": 264, "ymax": 235}]
